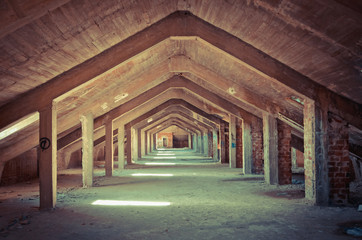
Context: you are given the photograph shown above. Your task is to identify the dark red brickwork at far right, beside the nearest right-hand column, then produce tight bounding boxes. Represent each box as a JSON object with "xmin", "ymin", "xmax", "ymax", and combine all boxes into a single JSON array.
[{"xmin": 328, "ymin": 113, "xmax": 352, "ymax": 204}]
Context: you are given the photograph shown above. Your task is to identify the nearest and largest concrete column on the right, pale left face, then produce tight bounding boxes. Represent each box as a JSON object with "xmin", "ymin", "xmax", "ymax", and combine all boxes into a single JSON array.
[{"xmin": 304, "ymin": 101, "xmax": 329, "ymax": 205}]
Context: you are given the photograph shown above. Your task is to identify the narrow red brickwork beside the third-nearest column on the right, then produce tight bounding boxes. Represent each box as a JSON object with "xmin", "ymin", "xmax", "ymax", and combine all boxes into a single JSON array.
[{"xmin": 251, "ymin": 119, "xmax": 264, "ymax": 174}]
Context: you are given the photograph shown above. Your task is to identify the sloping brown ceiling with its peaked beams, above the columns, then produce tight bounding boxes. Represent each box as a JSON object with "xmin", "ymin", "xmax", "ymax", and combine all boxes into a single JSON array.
[{"xmin": 0, "ymin": 0, "xmax": 362, "ymax": 162}]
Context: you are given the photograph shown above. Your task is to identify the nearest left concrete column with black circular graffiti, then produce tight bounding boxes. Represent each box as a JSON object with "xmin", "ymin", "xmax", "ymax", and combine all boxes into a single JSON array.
[{"xmin": 39, "ymin": 104, "xmax": 57, "ymax": 209}]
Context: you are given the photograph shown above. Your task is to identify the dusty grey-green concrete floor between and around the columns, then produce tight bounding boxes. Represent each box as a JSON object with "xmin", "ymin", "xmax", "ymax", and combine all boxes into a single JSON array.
[{"xmin": 0, "ymin": 158, "xmax": 362, "ymax": 240}]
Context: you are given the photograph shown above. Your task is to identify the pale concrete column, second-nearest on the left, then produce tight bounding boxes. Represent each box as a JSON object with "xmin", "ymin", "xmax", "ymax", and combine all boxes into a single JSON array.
[{"xmin": 80, "ymin": 113, "xmax": 94, "ymax": 188}]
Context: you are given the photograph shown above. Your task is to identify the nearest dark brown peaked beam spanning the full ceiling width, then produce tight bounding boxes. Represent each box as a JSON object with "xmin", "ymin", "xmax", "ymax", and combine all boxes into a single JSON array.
[{"xmin": 0, "ymin": 12, "xmax": 362, "ymax": 128}]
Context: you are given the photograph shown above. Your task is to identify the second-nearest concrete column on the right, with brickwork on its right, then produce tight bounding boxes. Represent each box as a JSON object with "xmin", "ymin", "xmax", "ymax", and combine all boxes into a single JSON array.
[{"xmin": 263, "ymin": 113, "xmax": 278, "ymax": 184}]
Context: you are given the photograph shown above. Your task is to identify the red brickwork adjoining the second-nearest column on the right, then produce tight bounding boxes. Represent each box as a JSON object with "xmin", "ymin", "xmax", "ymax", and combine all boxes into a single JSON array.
[{"xmin": 278, "ymin": 121, "xmax": 292, "ymax": 185}]
